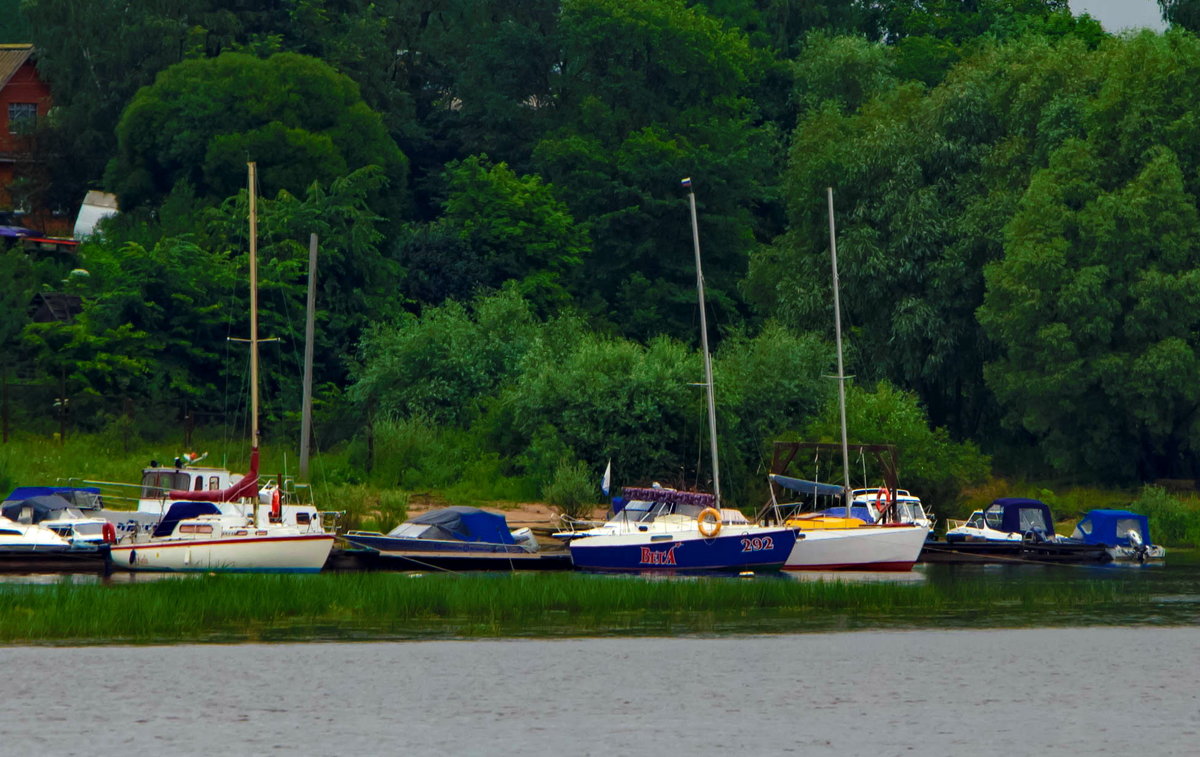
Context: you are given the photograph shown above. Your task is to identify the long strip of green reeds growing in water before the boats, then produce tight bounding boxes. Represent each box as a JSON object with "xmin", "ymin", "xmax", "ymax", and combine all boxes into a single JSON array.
[{"xmin": 0, "ymin": 573, "xmax": 1148, "ymax": 644}]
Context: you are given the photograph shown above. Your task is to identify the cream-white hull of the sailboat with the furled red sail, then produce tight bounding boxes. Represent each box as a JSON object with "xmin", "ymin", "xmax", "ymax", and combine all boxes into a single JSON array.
[{"xmin": 112, "ymin": 534, "xmax": 334, "ymax": 573}]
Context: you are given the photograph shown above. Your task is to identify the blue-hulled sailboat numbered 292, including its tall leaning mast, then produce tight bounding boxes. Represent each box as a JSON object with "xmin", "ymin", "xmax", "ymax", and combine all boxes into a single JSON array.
[{"xmin": 566, "ymin": 179, "xmax": 797, "ymax": 572}]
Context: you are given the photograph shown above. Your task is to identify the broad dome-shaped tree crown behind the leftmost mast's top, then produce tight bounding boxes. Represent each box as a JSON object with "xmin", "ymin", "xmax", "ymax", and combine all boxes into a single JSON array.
[{"xmin": 107, "ymin": 53, "xmax": 407, "ymax": 215}]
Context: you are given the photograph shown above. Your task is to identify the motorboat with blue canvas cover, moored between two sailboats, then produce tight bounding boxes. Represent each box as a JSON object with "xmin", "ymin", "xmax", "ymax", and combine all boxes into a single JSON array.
[{"xmin": 342, "ymin": 506, "xmax": 571, "ymax": 571}]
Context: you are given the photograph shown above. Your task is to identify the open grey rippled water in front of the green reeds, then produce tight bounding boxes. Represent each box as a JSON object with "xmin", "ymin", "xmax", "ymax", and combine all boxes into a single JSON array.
[{"xmin": 0, "ymin": 627, "xmax": 1200, "ymax": 757}]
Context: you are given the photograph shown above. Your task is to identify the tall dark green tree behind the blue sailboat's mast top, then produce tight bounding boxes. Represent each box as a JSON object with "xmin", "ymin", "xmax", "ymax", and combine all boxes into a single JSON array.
[{"xmin": 534, "ymin": 0, "xmax": 776, "ymax": 340}]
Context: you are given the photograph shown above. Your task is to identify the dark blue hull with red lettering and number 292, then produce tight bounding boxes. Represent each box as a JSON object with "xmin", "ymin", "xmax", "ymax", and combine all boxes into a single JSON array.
[{"xmin": 569, "ymin": 528, "xmax": 796, "ymax": 573}]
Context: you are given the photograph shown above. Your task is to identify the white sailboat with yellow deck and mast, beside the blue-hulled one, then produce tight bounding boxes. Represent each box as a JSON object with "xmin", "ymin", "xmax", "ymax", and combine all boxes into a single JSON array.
[{"xmin": 768, "ymin": 187, "xmax": 929, "ymax": 571}]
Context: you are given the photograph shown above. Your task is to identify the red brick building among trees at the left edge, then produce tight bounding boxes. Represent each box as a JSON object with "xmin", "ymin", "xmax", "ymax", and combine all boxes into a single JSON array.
[{"xmin": 0, "ymin": 44, "xmax": 53, "ymax": 226}]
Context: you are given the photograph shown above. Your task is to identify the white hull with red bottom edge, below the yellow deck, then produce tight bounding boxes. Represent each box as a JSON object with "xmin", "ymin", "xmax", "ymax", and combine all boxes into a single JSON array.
[{"xmin": 784, "ymin": 525, "xmax": 929, "ymax": 571}]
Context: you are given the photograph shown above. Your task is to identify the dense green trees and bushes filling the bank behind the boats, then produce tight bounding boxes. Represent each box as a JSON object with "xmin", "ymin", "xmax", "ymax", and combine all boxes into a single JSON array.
[{"xmin": 7, "ymin": 0, "xmax": 1200, "ymax": 518}]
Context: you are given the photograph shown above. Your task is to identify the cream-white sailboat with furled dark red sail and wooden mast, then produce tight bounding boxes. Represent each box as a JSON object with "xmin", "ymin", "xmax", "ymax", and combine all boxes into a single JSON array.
[{"xmin": 112, "ymin": 163, "xmax": 334, "ymax": 572}]
